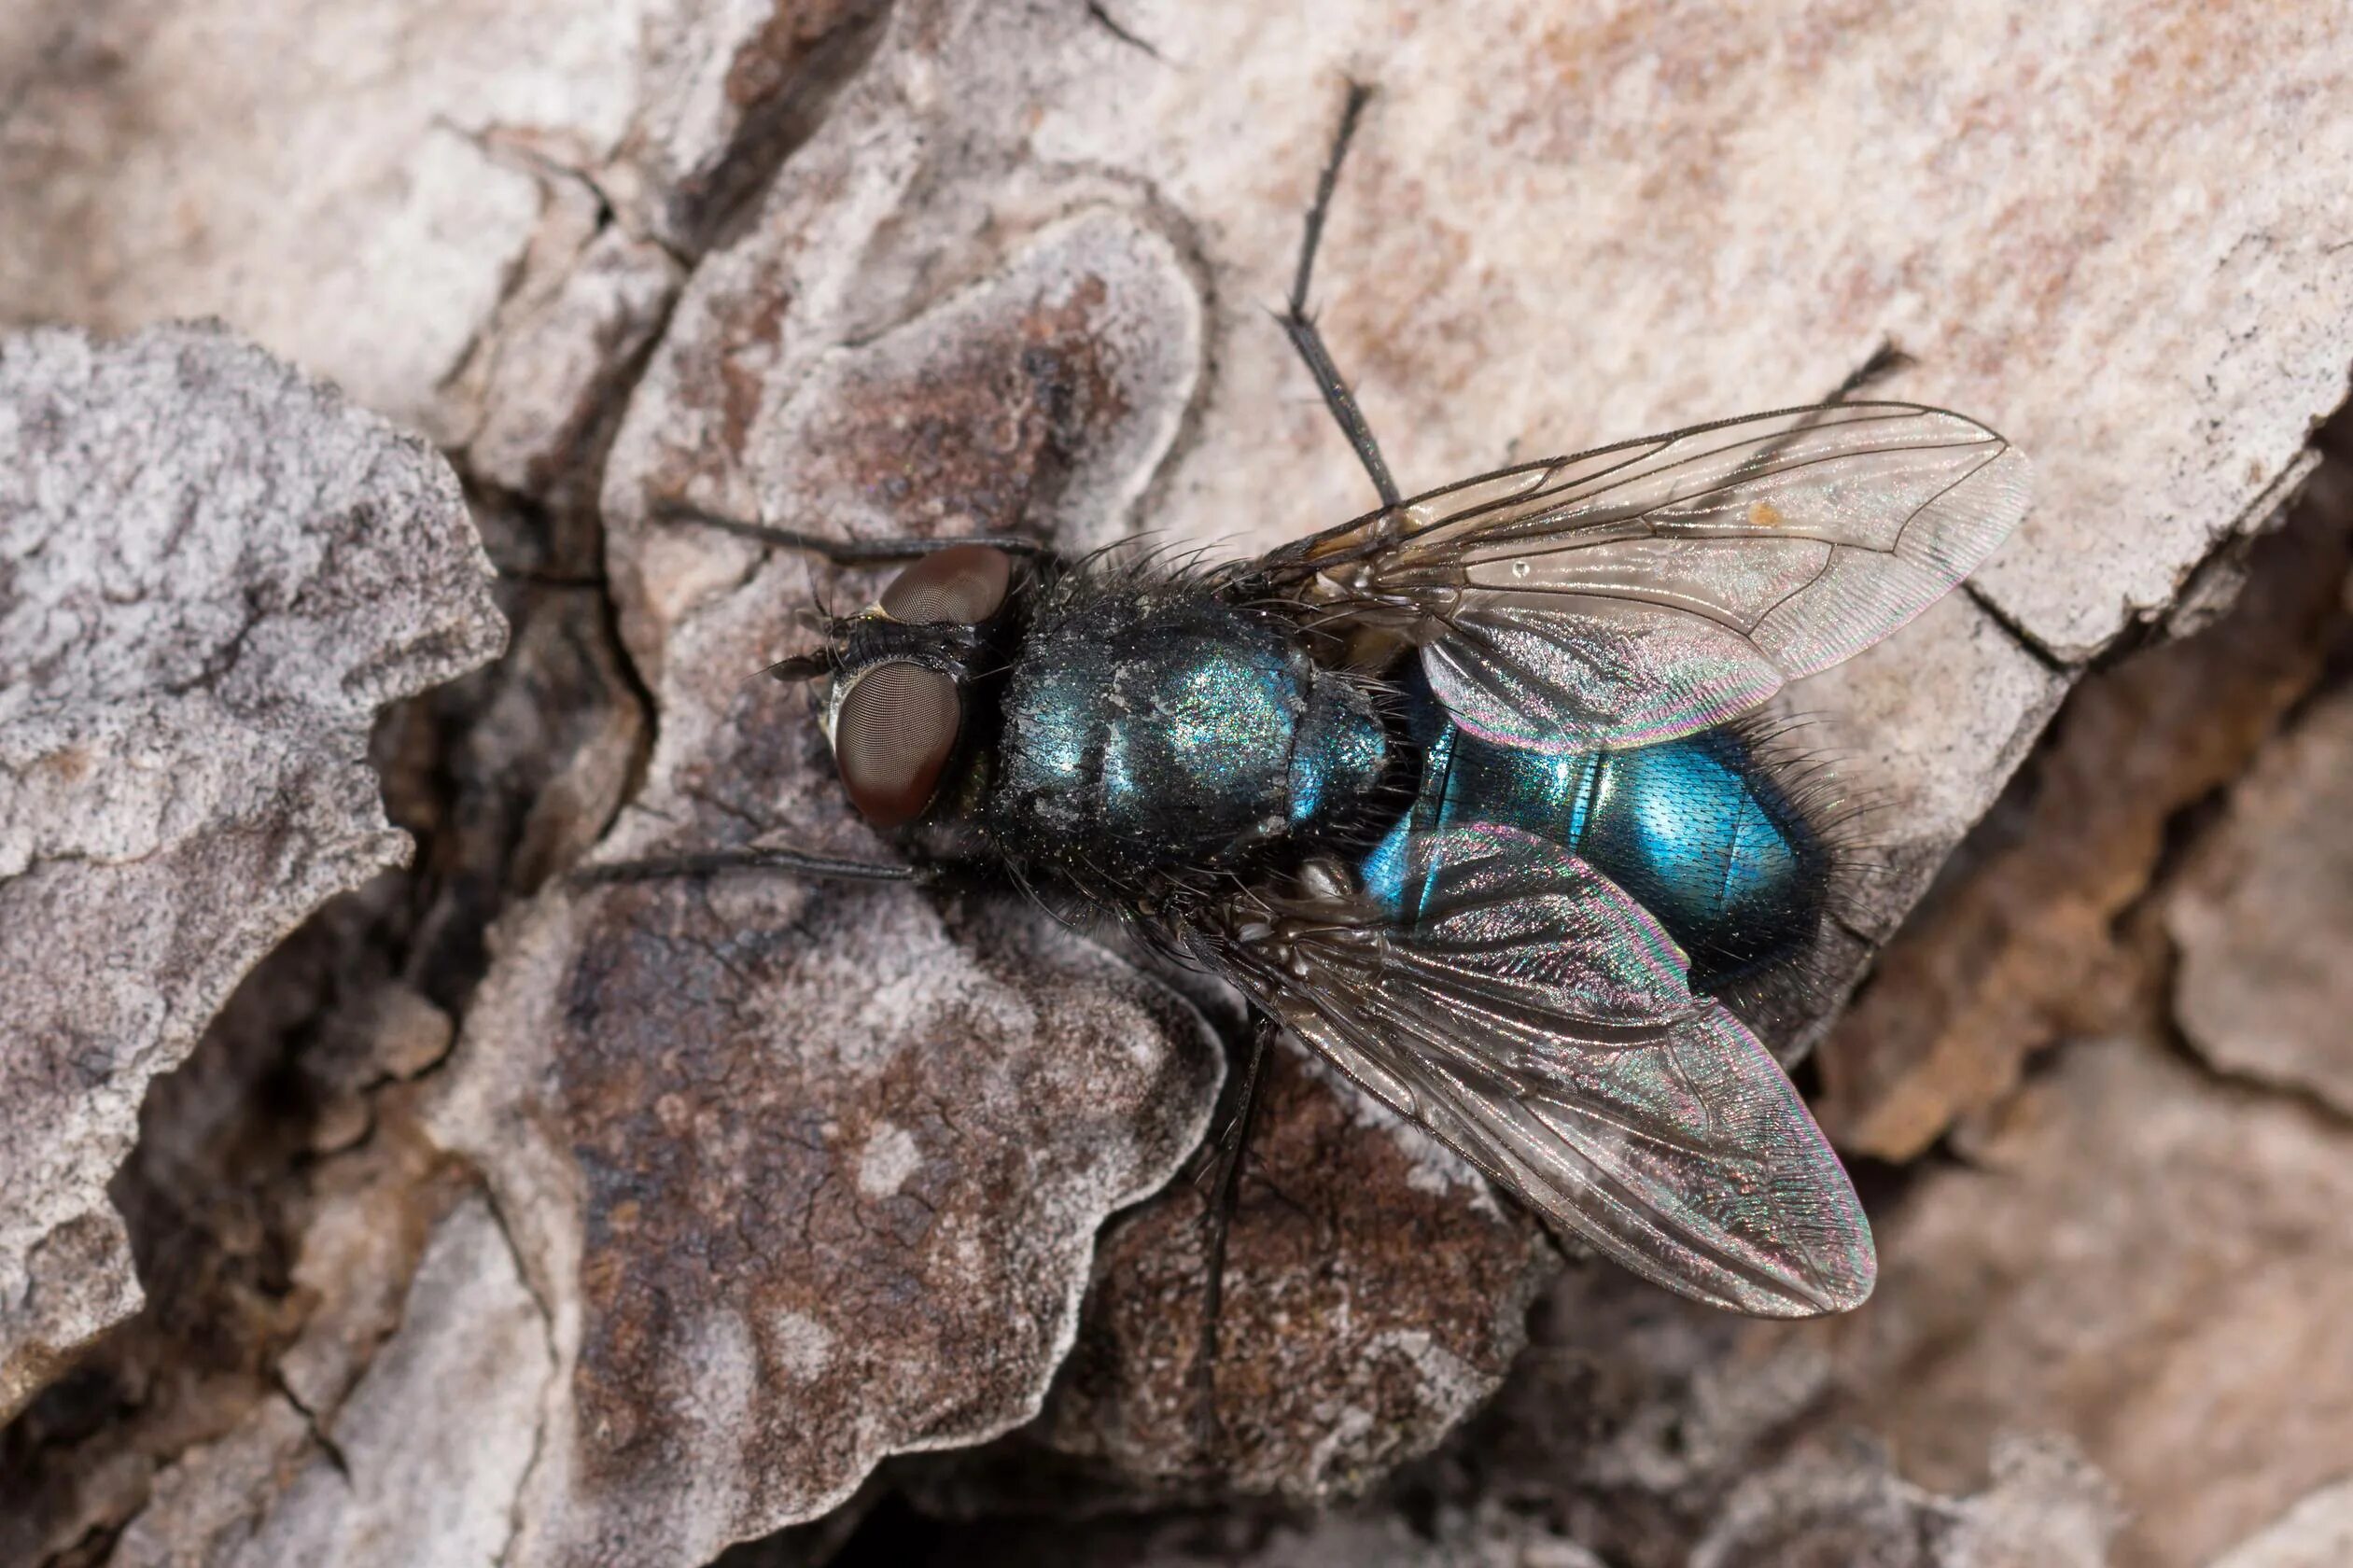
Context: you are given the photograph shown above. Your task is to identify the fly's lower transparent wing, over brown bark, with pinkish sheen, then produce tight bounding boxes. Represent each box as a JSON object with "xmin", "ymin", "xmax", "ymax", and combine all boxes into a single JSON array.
[{"xmin": 1210, "ymin": 824, "xmax": 1875, "ymax": 1316}]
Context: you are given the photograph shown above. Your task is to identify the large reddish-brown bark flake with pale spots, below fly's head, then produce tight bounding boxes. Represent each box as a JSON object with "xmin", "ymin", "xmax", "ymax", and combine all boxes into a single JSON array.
[{"xmin": 438, "ymin": 875, "xmax": 1216, "ymax": 1563}]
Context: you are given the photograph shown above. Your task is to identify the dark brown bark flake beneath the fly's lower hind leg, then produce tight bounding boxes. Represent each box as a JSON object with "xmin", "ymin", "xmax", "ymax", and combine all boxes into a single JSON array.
[{"xmin": 1021, "ymin": 1048, "xmax": 1558, "ymax": 1506}]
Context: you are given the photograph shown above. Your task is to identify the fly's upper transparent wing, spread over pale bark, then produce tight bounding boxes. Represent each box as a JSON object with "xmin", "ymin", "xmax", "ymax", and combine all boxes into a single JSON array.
[{"xmin": 1259, "ymin": 402, "xmax": 2028, "ymax": 751}]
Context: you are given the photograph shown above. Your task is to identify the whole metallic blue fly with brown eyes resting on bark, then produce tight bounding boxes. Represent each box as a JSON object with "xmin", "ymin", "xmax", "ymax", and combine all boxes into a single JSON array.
[{"xmin": 593, "ymin": 90, "xmax": 2026, "ymax": 1368}]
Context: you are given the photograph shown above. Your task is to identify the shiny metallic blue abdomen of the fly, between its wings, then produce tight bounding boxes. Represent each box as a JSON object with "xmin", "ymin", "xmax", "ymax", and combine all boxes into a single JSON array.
[{"xmin": 1363, "ymin": 687, "xmax": 1828, "ymax": 987}]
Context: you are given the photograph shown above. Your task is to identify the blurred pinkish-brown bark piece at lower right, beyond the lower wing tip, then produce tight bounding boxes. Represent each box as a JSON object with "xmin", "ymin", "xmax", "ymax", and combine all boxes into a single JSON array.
[{"xmin": 1824, "ymin": 1031, "xmax": 2353, "ymax": 1568}]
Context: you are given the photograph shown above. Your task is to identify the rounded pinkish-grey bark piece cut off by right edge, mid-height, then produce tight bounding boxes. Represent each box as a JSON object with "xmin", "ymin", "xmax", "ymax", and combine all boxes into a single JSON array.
[{"xmin": 2164, "ymin": 690, "xmax": 2353, "ymax": 1116}]
